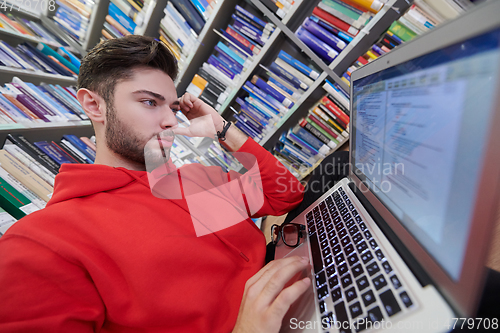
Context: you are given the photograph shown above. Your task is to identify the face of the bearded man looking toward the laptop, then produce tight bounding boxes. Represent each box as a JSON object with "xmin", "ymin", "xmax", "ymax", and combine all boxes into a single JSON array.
[{"xmin": 105, "ymin": 68, "xmax": 179, "ymax": 165}]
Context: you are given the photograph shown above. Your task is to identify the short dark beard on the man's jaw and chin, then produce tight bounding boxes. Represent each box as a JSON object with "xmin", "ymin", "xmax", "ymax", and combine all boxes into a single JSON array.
[{"xmin": 105, "ymin": 102, "xmax": 174, "ymax": 172}]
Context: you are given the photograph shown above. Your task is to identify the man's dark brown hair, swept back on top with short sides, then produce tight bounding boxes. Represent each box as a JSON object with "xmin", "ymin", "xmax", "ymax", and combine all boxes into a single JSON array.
[{"xmin": 78, "ymin": 35, "xmax": 178, "ymax": 103}]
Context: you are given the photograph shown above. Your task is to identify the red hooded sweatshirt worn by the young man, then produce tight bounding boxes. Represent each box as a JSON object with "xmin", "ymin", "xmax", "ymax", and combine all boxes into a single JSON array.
[{"xmin": 0, "ymin": 139, "xmax": 303, "ymax": 333}]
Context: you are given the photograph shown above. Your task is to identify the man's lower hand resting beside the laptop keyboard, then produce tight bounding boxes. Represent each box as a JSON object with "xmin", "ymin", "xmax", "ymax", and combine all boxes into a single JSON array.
[{"xmin": 233, "ymin": 257, "xmax": 311, "ymax": 333}]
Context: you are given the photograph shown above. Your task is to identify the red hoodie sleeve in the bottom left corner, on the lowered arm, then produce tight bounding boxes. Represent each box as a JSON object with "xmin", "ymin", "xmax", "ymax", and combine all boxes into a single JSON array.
[{"xmin": 0, "ymin": 233, "xmax": 105, "ymax": 333}]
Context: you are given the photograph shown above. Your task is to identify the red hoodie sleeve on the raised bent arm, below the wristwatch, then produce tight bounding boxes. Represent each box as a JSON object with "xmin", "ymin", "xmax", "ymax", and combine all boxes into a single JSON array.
[{"xmin": 229, "ymin": 138, "xmax": 304, "ymax": 217}]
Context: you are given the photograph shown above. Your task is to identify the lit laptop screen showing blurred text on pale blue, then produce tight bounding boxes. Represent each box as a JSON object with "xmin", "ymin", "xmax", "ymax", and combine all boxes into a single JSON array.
[{"xmin": 351, "ymin": 30, "xmax": 500, "ymax": 280}]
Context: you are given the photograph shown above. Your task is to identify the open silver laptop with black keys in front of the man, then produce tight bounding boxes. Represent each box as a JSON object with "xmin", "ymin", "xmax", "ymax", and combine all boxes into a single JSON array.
[{"xmin": 275, "ymin": 1, "xmax": 500, "ymax": 332}]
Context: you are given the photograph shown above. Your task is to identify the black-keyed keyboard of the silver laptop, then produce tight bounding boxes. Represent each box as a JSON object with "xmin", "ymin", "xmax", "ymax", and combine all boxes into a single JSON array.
[{"xmin": 306, "ymin": 188, "xmax": 414, "ymax": 333}]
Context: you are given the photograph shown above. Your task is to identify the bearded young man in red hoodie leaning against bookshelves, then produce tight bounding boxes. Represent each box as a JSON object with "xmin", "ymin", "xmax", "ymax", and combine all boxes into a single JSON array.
[{"xmin": 0, "ymin": 36, "xmax": 310, "ymax": 333}]
